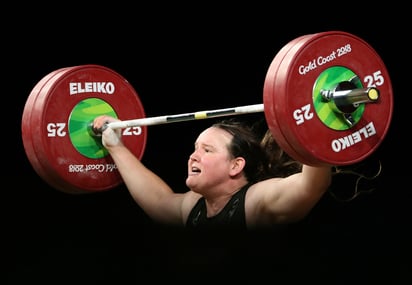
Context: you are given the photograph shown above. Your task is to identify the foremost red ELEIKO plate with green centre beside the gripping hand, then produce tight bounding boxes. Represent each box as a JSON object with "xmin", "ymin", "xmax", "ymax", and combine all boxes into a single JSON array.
[{"xmin": 23, "ymin": 65, "xmax": 147, "ymax": 193}]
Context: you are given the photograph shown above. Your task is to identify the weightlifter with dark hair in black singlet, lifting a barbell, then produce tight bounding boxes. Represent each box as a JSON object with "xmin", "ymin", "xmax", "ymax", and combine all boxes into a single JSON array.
[{"xmin": 93, "ymin": 115, "xmax": 332, "ymax": 229}]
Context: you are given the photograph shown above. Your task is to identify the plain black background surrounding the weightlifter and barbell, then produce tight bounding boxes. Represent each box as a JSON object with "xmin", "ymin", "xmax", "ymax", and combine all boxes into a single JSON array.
[{"xmin": 2, "ymin": 3, "xmax": 411, "ymax": 284}]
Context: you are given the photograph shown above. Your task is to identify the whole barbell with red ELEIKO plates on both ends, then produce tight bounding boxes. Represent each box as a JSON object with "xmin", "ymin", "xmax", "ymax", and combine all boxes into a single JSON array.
[{"xmin": 21, "ymin": 31, "xmax": 393, "ymax": 194}]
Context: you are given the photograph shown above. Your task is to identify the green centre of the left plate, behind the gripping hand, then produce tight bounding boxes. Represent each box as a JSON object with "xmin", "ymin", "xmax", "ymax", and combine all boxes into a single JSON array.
[{"xmin": 69, "ymin": 98, "xmax": 117, "ymax": 158}]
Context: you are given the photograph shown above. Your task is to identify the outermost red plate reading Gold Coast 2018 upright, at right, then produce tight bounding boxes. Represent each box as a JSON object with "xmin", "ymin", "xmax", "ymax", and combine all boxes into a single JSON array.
[{"xmin": 273, "ymin": 31, "xmax": 393, "ymax": 165}]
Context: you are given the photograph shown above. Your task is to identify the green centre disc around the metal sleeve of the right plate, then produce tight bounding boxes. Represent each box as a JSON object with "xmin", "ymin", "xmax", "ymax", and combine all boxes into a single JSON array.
[{"xmin": 313, "ymin": 66, "xmax": 365, "ymax": 130}]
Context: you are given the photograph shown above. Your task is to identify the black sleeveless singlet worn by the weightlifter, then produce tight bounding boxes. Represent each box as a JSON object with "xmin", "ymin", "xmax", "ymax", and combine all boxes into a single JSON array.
[{"xmin": 186, "ymin": 184, "xmax": 250, "ymax": 229}]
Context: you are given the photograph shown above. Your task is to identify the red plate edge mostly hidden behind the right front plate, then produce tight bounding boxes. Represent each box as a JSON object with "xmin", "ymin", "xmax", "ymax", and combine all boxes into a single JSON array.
[{"xmin": 263, "ymin": 35, "xmax": 322, "ymax": 164}]
